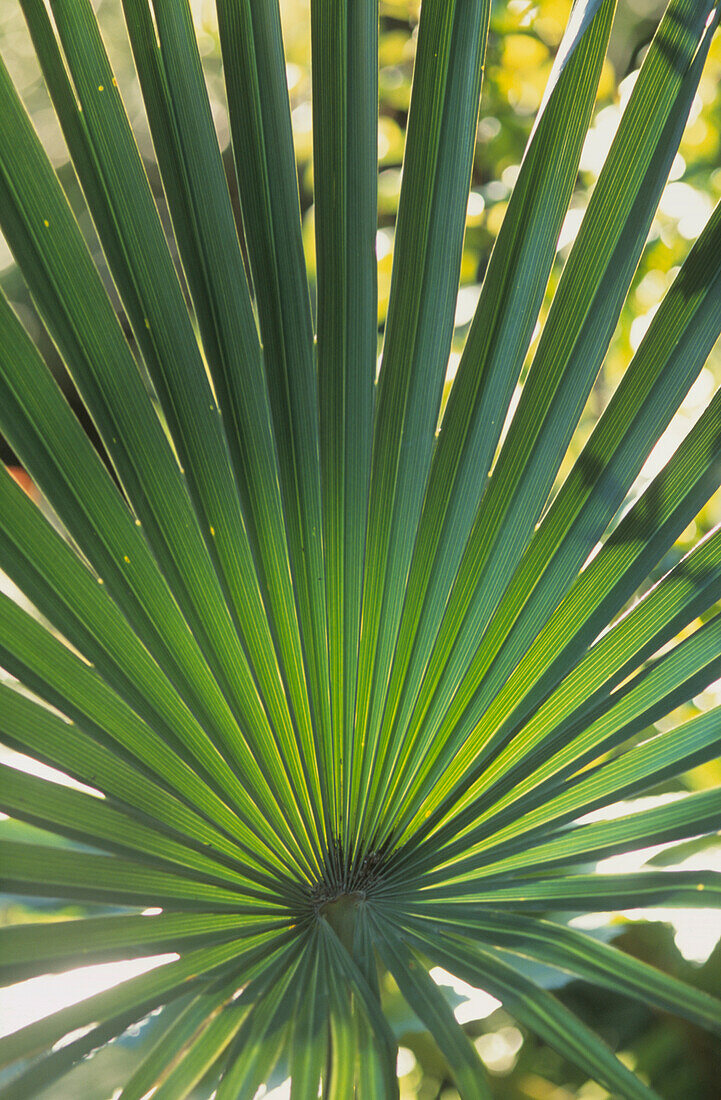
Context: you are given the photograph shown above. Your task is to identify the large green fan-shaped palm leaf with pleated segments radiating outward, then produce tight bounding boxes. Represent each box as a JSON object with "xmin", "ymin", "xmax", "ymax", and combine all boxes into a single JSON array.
[{"xmin": 0, "ymin": 0, "xmax": 721, "ymax": 1100}]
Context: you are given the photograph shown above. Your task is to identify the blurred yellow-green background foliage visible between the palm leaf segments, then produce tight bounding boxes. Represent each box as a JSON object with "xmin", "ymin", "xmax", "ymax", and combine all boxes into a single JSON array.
[{"xmin": 0, "ymin": 0, "xmax": 721, "ymax": 1100}]
